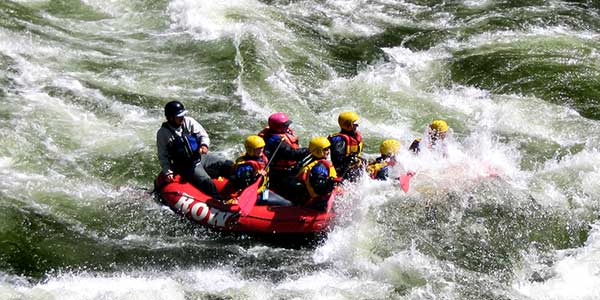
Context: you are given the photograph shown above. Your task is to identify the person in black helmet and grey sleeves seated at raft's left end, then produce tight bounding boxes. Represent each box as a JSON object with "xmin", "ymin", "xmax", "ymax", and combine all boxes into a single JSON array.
[{"xmin": 156, "ymin": 101, "xmax": 233, "ymax": 200}]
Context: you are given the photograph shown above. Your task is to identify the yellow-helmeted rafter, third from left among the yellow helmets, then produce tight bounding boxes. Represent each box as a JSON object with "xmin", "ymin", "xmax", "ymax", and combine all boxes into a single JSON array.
[{"xmin": 328, "ymin": 111, "xmax": 365, "ymax": 181}]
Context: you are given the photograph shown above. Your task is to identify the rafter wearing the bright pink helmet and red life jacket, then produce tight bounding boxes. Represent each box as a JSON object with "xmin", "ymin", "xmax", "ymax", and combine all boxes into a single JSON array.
[{"xmin": 258, "ymin": 112, "xmax": 310, "ymax": 195}]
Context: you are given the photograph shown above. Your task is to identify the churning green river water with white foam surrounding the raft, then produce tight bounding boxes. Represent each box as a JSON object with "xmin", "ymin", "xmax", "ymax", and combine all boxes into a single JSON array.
[{"xmin": 0, "ymin": 0, "xmax": 600, "ymax": 300}]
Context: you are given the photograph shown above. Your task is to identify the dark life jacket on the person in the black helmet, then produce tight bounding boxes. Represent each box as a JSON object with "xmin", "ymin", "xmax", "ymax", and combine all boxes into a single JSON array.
[{"xmin": 162, "ymin": 122, "xmax": 200, "ymax": 169}]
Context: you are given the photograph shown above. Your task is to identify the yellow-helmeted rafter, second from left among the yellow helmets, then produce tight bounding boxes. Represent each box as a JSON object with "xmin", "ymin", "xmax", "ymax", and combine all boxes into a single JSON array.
[{"xmin": 296, "ymin": 136, "xmax": 339, "ymax": 210}]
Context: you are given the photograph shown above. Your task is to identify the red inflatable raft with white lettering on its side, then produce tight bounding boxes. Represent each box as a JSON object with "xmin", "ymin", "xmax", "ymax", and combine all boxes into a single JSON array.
[{"xmin": 156, "ymin": 176, "xmax": 339, "ymax": 234}]
